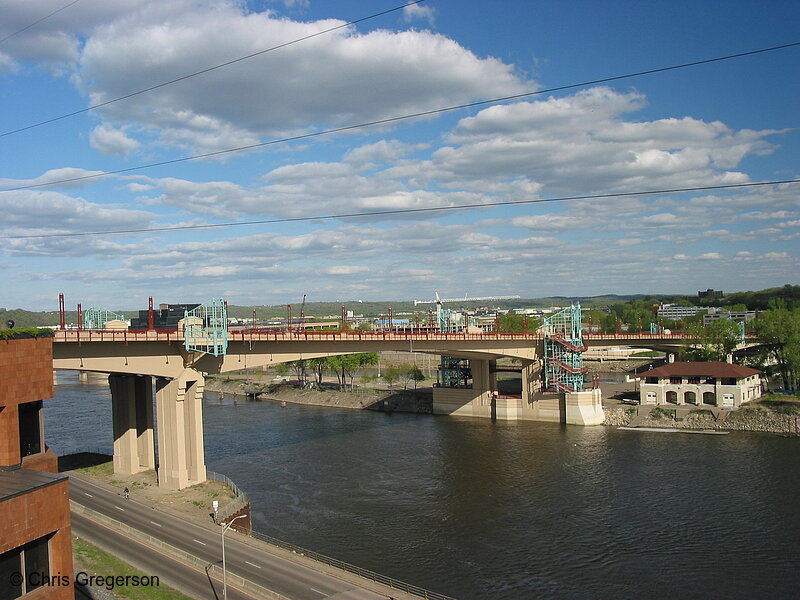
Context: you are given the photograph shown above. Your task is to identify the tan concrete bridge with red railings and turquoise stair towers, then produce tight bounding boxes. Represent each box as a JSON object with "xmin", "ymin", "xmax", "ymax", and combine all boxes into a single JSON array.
[{"xmin": 53, "ymin": 302, "xmax": 756, "ymax": 489}]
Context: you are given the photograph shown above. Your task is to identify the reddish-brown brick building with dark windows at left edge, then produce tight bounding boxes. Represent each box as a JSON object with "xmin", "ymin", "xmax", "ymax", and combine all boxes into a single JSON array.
[{"xmin": 0, "ymin": 337, "xmax": 74, "ymax": 600}]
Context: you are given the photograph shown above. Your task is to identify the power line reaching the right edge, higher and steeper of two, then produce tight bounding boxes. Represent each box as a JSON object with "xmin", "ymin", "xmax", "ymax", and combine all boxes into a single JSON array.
[{"xmin": 0, "ymin": 42, "xmax": 800, "ymax": 192}]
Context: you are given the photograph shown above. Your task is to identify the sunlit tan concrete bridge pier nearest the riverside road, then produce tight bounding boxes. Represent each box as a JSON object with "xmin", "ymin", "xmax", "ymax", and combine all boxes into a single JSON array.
[{"xmin": 156, "ymin": 369, "xmax": 206, "ymax": 490}]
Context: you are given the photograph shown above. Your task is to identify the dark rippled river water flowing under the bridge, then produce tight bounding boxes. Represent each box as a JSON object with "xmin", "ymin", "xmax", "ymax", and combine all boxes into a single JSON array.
[{"xmin": 45, "ymin": 372, "xmax": 800, "ymax": 600}]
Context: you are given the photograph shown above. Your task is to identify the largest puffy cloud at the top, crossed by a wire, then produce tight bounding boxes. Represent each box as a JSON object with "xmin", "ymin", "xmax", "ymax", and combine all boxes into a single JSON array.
[{"xmin": 69, "ymin": 0, "xmax": 532, "ymax": 155}]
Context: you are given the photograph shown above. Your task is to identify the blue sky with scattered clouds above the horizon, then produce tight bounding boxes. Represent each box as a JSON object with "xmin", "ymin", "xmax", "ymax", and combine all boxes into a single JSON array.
[{"xmin": 0, "ymin": 0, "xmax": 800, "ymax": 310}]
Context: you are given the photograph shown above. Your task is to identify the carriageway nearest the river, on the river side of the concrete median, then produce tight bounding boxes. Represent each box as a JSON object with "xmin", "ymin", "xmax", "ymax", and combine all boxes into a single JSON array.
[{"xmin": 70, "ymin": 473, "xmax": 409, "ymax": 600}]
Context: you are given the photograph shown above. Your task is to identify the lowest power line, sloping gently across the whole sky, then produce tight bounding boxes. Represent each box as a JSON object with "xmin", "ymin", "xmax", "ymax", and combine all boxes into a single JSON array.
[{"xmin": 0, "ymin": 179, "xmax": 800, "ymax": 240}]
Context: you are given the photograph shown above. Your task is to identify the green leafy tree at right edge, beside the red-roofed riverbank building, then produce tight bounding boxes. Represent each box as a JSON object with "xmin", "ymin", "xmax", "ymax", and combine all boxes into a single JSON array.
[{"xmin": 753, "ymin": 303, "xmax": 800, "ymax": 389}]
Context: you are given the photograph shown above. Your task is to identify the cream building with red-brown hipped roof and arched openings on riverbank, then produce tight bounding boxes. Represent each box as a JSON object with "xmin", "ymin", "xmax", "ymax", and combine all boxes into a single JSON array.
[{"xmin": 639, "ymin": 362, "xmax": 762, "ymax": 408}]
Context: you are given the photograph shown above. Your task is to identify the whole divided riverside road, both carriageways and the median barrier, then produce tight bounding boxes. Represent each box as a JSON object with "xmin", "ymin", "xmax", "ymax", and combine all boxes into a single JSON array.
[{"xmin": 69, "ymin": 472, "xmax": 445, "ymax": 600}]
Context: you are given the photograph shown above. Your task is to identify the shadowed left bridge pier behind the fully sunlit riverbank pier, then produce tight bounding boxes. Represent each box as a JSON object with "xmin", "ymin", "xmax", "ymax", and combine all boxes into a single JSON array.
[{"xmin": 108, "ymin": 374, "xmax": 155, "ymax": 475}]
